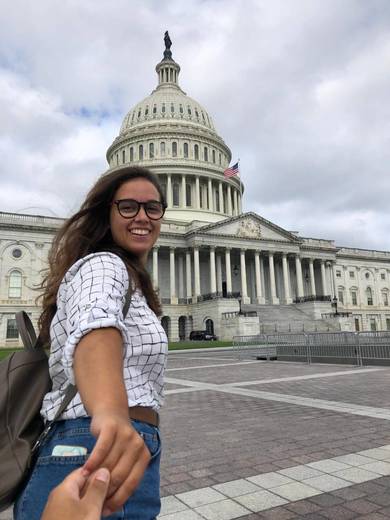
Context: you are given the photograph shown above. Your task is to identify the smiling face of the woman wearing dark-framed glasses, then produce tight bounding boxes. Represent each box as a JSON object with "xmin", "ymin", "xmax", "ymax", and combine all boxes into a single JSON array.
[{"xmin": 110, "ymin": 177, "xmax": 161, "ymax": 263}]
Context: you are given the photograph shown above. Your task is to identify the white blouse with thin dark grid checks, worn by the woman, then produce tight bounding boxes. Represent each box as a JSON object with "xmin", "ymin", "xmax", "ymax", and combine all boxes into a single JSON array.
[{"xmin": 41, "ymin": 253, "xmax": 167, "ymax": 420}]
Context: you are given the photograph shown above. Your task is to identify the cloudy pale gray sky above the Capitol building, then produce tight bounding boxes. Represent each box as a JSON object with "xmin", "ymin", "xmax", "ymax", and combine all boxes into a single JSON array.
[{"xmin": 0, "ymin": 0, "xmax": 390, "ymax": 250}]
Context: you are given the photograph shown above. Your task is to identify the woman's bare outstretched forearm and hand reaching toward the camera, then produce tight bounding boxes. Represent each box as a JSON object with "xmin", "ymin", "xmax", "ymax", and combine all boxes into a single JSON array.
[{"xmin": 74, "ymin": 328, "xmax": 150, "ymax": 514}]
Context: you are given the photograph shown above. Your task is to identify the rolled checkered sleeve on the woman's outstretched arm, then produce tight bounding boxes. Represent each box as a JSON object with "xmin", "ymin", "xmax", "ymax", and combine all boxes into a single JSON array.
[{"xmin": 60, "ymin": 253, "xmax": 129, "ymax": 384}]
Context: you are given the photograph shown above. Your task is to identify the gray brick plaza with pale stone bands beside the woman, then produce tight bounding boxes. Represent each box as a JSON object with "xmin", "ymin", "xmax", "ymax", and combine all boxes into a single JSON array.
[{"xmin": 0, "ymin": 349, "xmax": 390, "ymax": 520}]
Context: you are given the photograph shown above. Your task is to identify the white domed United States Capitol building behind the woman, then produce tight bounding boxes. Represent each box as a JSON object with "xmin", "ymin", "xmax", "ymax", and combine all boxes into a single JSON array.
[{"xmin": 0, "ymin": 37, "xmax": 390, "ymax": 347}]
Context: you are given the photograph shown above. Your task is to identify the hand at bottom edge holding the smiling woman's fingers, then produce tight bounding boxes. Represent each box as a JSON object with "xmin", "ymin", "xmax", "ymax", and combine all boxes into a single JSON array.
[{"xmin": 41, "ymin": 468, "xmax": 110, "ymax": 520}]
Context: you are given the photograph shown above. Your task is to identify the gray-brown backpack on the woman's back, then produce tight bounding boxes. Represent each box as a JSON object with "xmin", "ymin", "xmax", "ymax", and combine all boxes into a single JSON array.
[{"xmin": 0, "ymin": 311, "xmax": 77, "ymax": 511}]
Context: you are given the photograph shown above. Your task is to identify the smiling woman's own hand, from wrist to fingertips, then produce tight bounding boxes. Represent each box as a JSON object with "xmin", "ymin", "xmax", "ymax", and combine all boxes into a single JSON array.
[{"xmin": 84, "ymin": 410, "xmax": 151, "ymax": 515}]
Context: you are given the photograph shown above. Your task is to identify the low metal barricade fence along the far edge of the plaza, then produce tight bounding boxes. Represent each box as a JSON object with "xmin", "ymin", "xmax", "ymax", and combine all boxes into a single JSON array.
[{"xmin": 233, "ymin": 331, "xmax": 390, "ymax": 366}]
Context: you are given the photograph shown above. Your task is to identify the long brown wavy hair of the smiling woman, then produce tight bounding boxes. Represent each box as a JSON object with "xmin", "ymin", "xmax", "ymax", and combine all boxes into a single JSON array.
[{"xmin": 38, "ymin": 166, "xmax": 165, "ymax": 342}]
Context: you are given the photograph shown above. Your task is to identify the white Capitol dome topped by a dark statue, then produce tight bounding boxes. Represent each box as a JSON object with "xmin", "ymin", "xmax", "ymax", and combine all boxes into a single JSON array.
[{"xmin": 107, "ymin": 36, "xmax": 243, "ymax": 222}]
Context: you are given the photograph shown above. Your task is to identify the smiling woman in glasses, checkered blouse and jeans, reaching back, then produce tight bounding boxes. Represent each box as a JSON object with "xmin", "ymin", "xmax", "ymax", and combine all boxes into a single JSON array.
[{"xmin": 15, "ymin": 167, "xmax": 167, "ymax": 520}]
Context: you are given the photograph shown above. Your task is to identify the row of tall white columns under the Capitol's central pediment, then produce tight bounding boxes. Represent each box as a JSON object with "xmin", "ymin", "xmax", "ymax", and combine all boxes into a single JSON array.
[{"xmin": 152, "ymin": 246, "xmax": 335, "ymax": 305}]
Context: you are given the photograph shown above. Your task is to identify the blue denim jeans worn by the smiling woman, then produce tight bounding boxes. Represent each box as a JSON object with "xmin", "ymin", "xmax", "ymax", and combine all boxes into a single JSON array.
[{"xmin": 14, "ymin": 417, "xmax": 161, "ymax": 520}]
